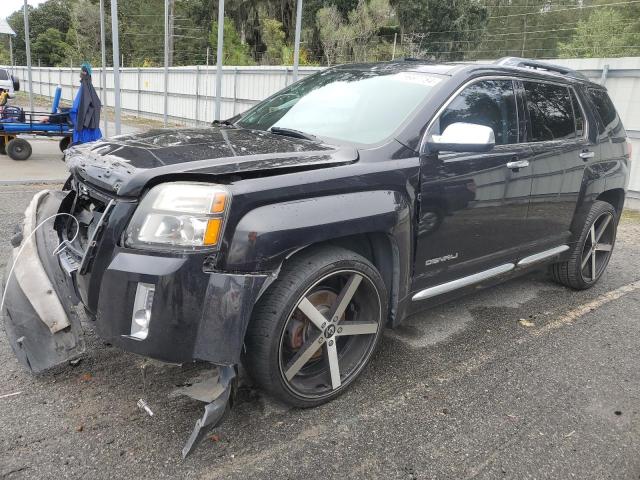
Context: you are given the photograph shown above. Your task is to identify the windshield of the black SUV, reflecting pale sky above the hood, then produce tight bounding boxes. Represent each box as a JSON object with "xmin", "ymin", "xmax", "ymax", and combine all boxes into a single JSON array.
[{"xmin": 237, "ymin": 69, "xmax": 444, "ymax": 144}]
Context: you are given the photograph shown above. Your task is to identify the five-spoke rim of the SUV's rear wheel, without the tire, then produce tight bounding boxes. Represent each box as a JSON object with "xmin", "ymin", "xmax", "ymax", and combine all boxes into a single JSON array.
[{"xmin": 580, "ymin": 212, "xmax": 615, "ymax": 283}]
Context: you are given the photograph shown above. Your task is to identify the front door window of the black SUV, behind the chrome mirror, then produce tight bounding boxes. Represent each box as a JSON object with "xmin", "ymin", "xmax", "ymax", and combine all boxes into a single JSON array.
[{"xmin": 439, "ymin": 80, "xmax": 518, "ymax": 145}]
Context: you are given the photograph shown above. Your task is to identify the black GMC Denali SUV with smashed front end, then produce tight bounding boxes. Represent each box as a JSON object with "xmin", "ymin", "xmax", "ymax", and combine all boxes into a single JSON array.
[{"xmin": 5, "ymin": 58, "xmax": 630, "ymax": 454}]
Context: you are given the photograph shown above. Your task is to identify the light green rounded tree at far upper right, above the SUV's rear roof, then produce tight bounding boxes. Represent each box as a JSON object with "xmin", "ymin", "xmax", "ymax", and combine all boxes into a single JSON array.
[{"xmin": 558, "ymin": 8, "xmax": 640, "ymax": 58}]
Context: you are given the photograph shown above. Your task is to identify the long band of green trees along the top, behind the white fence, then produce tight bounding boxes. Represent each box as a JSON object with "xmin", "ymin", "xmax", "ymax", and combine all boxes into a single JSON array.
[{"xmin": 0, "ymin": 0, "xmax": 640, "ymax": 67}]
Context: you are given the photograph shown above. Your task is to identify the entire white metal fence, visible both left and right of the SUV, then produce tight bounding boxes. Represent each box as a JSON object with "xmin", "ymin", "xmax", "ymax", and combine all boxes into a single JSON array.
[{"xmin": 7, "ymin": 57, "xmax": 640, "ymax": 204}]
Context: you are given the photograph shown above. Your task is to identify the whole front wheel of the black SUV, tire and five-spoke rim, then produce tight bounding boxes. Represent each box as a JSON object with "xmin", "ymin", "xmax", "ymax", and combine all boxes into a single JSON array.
[{"xmin": 245, "ymin": 247, "xmax": 388, "ymax": 408}]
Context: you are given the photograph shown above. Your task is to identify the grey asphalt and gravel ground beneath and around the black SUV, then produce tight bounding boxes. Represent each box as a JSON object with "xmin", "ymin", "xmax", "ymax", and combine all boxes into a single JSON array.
[{"xmin": 0, "ymin": 186, "xmax": 640, "ymax": 480}]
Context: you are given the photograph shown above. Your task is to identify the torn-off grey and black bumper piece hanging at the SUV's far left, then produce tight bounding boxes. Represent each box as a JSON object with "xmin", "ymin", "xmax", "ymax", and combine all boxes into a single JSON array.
[{"xmin": 2, "ymin": 190, "xmax": 85, "ymax": 373}]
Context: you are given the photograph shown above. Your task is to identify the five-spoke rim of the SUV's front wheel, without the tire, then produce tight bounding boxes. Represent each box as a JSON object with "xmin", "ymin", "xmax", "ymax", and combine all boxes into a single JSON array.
[{"xmin": 278, "ymin": 270, "xmax": 382, "ymax": 399}]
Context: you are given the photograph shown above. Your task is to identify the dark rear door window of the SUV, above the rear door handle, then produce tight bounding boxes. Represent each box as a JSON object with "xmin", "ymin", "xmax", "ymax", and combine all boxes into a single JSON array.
[{"xmin": 523, "ymin": 82, "xmax": 576, "ymax": 142}]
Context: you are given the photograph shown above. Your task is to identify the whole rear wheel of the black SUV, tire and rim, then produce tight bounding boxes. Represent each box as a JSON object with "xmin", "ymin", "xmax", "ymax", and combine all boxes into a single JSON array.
[{"xmin": 551, "ymin": 200, "xmax": 618, "ymax": 290}]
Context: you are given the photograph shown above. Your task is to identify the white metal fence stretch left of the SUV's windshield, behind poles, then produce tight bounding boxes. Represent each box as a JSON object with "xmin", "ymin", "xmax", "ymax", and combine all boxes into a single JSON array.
[{"xmin": 8, "ymin": 66, "xmax": 320, "ymax": 125}]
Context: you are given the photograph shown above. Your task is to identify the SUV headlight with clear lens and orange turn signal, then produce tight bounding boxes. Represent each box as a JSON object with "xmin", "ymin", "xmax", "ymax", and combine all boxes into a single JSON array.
[{"xmin": 124, "ymin": 182, "xmax": 231, "ymax": 250}]
